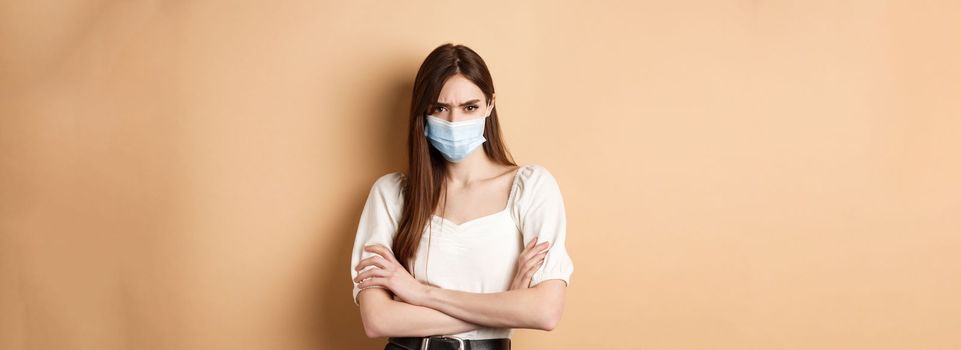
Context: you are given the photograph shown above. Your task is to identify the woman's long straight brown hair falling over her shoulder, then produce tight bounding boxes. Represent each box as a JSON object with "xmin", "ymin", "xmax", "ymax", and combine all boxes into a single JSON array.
[{"xmin": 392, "ymin": 43, "xmax": 517, "ymax": 271}]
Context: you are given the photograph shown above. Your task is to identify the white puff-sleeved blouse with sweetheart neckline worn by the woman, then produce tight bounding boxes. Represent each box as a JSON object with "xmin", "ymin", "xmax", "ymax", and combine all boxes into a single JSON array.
[{"xmin": 350, "ymin": 164, "xmax": 574, "ymax": 339}]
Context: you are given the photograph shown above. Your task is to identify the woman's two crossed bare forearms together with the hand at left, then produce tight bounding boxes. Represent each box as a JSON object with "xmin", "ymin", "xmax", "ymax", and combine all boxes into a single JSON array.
[{"xmin": 358, "ymin": 242, "xmax": 567, "ymax": 338}]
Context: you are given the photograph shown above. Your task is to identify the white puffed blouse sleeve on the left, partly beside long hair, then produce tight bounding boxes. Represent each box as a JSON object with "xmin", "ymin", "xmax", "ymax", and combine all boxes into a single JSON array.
[{"xmin": 350, "ymin": 172, "xmax": 403, "ymax": 305}]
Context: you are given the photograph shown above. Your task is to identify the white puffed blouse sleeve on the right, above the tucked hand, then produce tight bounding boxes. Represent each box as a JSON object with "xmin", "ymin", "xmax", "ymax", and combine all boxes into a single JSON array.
[{"xmin": 518, "ymin": 164, "xmax": 574, "ymax": 287}]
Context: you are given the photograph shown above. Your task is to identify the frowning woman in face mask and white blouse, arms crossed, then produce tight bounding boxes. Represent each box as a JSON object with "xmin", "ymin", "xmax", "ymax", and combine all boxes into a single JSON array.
[{"xmin": 351, "ymin": 44, "xmax": 574, "ymax": 350}]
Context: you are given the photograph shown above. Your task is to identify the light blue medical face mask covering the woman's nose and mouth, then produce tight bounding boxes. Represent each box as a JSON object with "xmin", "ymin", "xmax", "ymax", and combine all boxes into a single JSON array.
[{"xmin": 424, "ymin": 106, "xmax": 488, "ymax": 163}]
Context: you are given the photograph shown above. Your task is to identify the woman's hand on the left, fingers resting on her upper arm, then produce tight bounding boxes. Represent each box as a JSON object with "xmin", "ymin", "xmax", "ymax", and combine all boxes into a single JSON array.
[{"xmin": 354, "ymin": 244, "xmax": 430, "ymax": 305}]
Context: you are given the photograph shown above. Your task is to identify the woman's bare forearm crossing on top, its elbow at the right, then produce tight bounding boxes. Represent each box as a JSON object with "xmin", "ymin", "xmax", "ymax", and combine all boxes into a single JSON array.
[{"xmin": 419, "ymin": 288, "xmax": 559, "ymax": 330}]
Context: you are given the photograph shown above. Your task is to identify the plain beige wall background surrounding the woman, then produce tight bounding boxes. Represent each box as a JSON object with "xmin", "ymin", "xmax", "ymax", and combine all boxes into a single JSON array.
[{"xmin": 0, "ymin": 0, "xmax": 961, "ymax": 350}]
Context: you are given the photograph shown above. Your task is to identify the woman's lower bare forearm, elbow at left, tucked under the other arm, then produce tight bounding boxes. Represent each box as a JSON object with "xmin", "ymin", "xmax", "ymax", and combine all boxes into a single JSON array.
[{"xmin": 359, "ymin": 288, "xmax": 479, "ymax": 338}]
